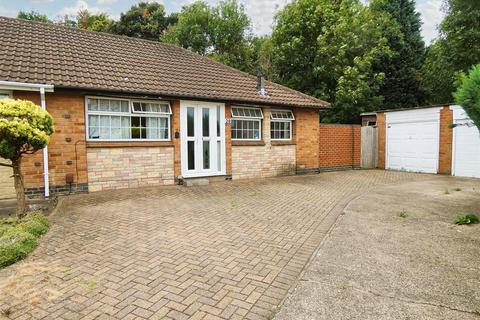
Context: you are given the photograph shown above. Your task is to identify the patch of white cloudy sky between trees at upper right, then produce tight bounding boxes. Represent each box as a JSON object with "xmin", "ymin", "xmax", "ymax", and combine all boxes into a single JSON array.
[{"xmin": 417, "ymin": 0, "xmax": 445, "ymax": 44}]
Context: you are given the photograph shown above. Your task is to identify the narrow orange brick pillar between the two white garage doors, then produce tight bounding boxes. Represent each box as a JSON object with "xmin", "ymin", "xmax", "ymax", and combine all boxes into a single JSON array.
[{"xmin": 438, "ymin": 106, "xmax": 453, "ymax": 174}]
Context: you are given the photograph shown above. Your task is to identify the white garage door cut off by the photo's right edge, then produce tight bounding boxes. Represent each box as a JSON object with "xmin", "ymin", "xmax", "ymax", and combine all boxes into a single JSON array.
[{"xmin": 452, "ymin": 106, "xmax": 480, "ymax": 178}]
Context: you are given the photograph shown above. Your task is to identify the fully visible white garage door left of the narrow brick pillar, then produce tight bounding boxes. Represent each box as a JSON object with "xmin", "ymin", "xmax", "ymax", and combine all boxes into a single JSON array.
[{"xmin": 386, "ymin": 108, "xmax": 440, "ymax": 173}]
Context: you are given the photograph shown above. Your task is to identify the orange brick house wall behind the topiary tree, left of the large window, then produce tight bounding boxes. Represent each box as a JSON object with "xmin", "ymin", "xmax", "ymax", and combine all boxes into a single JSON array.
[{"xmin": 13, "ymin": 91, "xmax": 87, "ymax": 194}]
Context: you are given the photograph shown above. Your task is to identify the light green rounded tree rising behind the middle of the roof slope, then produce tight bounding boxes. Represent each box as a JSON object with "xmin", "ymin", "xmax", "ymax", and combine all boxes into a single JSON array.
[{"xmin": 161, "ymin": 0, "xmax": 255, "ymax": 72}]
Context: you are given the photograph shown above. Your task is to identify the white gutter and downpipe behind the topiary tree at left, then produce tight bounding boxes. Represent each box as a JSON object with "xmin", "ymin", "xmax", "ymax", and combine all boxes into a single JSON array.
[{"xmin": 0, "ymin": 81, "xmax": 53, "ymax": 198}]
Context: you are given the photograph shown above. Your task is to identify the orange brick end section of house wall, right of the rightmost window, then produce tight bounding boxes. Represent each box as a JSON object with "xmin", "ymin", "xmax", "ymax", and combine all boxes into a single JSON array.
[{"xmin": 294, "ymin": 108, "xmax": 320, "ymax": 173}]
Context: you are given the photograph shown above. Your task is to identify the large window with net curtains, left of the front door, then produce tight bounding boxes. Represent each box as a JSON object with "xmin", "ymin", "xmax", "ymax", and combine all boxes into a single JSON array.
[{"xmin": 87, "ymin": 97, "xmax": 172, "ymax": 141}]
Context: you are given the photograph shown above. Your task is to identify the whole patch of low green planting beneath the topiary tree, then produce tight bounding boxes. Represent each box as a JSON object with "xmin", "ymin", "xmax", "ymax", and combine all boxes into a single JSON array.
[{"xmin": 0, "ymin": 213, "xmax": 49, "ymax": 268}]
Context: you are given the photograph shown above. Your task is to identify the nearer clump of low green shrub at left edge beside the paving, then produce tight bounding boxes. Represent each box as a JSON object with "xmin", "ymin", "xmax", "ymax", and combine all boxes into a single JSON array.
[{"xmin": 0, "ymin": 228, "xmax": 37, "ymax": 268}]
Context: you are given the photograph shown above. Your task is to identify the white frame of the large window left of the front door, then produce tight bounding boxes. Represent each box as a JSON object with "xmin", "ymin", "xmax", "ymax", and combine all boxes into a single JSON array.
[{"xmin": 85, "ymin": 96, "xmax": 172, "ymax": 142}]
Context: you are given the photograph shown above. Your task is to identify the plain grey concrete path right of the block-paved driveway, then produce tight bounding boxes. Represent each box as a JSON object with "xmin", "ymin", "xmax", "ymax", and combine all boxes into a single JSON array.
[{"xmin": 275, "ymin": 176, "xmax": 480, "ymax": 320}]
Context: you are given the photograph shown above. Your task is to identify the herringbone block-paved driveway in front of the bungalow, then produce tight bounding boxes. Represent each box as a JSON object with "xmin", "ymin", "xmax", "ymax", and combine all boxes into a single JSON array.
[{"xmin": 0, "ymin": 170, "xmax": 432, "ymax": 319}]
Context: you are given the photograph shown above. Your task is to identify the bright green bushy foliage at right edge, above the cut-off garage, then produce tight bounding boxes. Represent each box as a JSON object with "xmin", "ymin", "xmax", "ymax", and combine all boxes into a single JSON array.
[{"xmin": 454, "ymin": 64, "xmax": 480, "ymax": 129}]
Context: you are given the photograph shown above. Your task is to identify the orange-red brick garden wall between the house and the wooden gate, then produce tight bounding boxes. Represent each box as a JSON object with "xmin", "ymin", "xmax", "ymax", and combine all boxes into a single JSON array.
[{"xmin": 319, "ymin": 124, "xmax": 361, "ymax": 171}]
